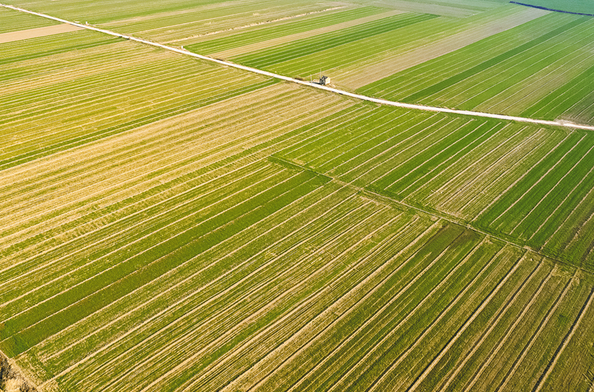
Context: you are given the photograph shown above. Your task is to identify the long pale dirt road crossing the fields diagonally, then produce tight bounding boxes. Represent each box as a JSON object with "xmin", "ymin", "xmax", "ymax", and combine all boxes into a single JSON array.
[{"xmin": 0, "ymin": 4, "xmax": 594, "ymax": 131}]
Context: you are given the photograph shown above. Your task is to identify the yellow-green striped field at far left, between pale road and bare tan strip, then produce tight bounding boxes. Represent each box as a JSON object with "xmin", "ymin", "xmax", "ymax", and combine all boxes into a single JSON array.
[{"xmin": 0, "ymin": 27, "xmax": 273, "ymax": 168}]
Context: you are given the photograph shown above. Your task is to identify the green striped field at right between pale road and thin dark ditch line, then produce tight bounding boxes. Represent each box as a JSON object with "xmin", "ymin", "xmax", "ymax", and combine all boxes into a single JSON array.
[{"xmin": 278, "ymin": 105, "xmax": 594, "ymax": 268}]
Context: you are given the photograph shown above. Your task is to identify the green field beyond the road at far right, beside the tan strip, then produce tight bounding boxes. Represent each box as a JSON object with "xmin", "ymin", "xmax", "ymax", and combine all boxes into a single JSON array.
[{"xmin": 359, "ymin": 13, "xmax": 594, "ymax": 123}]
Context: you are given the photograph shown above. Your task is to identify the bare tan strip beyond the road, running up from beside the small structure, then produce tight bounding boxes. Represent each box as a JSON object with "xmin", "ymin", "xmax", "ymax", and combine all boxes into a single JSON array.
[{"xmin": 334, "ymin": 9, "xmax": 547, "ymax": 89}]
